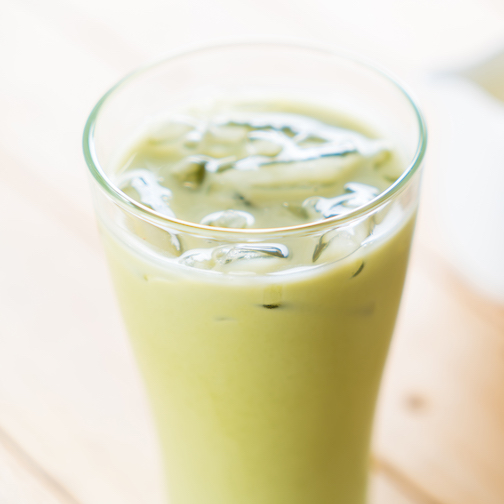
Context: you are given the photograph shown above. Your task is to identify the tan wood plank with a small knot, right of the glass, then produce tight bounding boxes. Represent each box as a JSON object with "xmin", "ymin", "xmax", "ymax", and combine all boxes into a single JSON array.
[{"xmin": 376, "ymin": 241, "xmax": 504, "ymax": 504}]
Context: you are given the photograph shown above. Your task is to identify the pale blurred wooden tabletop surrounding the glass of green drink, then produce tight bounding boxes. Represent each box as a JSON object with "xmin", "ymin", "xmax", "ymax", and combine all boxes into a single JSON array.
[{"xmin": 0, "ymin": 0, "xmax": 504, "ymax": 504}]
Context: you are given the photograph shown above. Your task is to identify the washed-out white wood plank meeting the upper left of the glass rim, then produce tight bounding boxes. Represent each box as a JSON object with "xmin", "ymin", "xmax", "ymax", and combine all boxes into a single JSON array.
[{"xmin": 0, "ymin": 0, "xmax": 128, "ymax": 216}]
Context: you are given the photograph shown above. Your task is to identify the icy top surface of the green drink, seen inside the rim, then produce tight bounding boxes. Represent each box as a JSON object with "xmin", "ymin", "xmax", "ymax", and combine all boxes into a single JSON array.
[{"xmin": 117, "ymin": 102, "xmax": 401, "ymax": 232}]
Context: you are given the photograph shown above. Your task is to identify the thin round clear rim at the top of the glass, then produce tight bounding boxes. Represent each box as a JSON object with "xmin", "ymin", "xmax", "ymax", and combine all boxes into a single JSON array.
[{"xmin": 82, "ymin": 38, "xmax": 427, "ymax": 238}]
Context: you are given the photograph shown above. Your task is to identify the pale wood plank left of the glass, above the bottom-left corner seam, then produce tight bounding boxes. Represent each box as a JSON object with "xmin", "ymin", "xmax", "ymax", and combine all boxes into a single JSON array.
[{"xmin": 0, "ymin": 156, "xmax": 165, "ymax": 504}]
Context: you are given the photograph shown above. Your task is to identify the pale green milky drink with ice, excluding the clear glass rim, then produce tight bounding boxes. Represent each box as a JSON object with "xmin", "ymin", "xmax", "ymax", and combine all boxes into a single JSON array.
[{"xmin": 102, "ymin": 99, "xmax": 414, "ymax": 504}]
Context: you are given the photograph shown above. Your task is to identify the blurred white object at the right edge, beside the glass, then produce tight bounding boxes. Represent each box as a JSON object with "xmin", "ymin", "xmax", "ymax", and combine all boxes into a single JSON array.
[{"xmin": 429, "ymin": 52, "xmax": 504, "ymax": 303}]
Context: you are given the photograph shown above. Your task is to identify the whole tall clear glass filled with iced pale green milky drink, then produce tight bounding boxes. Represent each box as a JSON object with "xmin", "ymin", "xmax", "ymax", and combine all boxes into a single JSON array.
[{"xmin": 85, "ymin": 44, "xmax": 424, "ymax": 504}]
